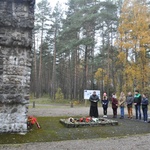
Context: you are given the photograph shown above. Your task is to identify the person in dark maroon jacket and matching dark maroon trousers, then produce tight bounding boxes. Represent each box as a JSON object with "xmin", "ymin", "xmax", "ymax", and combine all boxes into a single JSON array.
[{"xmin": 112, "ymin": 94, "xmax": 118, "ymax": 118}]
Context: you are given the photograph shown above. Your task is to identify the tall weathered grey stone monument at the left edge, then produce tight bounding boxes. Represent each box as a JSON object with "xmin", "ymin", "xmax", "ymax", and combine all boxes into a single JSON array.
[{"xmin": 0, "ymin": 0, "xmax": 35, "ymax": 133}]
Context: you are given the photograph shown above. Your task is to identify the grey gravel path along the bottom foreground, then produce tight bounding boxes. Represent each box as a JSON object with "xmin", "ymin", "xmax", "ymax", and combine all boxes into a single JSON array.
[{"xmin": 0, "ymin": 135, "xmax": 150, "ymax": 150}]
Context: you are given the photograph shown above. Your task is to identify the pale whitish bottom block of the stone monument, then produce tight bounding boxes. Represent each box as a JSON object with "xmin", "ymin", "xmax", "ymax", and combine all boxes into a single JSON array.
[{"xmin": 0, "ymin": 104, "xmax": 27, "ymax": 132}]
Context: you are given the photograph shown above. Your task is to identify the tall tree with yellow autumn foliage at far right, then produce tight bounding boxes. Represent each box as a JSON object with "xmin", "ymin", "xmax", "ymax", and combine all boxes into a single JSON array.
[{"xmin": 116, "ymin": 0, "xmax": 150, "ymax": 91}]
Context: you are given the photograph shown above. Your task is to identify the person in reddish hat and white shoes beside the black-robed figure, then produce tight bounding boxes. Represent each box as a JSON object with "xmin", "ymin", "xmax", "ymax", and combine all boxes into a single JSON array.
[{"xmin": 102, "ymin": 93, "xmax": 109, "ymax": 117}]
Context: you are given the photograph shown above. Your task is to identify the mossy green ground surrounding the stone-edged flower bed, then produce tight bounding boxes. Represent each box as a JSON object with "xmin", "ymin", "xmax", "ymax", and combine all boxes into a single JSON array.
[{"xmin": 0, "ymin": 116, "xmax": 150, "ymax": 144}]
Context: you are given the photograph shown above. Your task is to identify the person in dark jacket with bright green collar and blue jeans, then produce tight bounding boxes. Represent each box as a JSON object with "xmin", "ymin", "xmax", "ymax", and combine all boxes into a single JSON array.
[{"xmin": 134, "ymin": 90, "xmax": 141, "ymax": 120}]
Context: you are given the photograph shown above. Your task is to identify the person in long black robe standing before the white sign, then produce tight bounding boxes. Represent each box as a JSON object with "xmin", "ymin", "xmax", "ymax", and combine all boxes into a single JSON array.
[{"xmin": 89, "ymin": 91, "xmax": 99, "ymax": 118}]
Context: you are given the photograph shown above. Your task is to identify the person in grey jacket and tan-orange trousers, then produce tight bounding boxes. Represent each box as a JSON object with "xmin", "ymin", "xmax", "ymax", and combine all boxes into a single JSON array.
[{"xmin": 126, "ymin": 92, "xmax": 133, "ymax": 119}]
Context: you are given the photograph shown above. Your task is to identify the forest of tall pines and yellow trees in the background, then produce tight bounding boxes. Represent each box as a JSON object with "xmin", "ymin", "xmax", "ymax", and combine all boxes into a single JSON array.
[{"xmin": 31, "ymin": 0, "xmax": 150, "ymax": 100}]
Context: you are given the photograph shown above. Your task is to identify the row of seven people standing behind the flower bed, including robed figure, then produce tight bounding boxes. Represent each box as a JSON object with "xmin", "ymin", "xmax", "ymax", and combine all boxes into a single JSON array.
[{"xmin": 89, "ymin": 90, "xmax": 148, "ymax": 122}]
